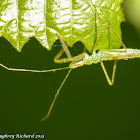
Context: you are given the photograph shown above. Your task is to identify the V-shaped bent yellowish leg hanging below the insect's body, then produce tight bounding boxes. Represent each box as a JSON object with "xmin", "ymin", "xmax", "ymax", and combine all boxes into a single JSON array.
[{"xmin": 101, "ymin": 60, "xmax": 117, "ymax": 85}]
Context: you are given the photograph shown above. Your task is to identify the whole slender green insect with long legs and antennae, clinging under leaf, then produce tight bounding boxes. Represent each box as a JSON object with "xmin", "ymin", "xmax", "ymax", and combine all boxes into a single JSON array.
[{"xmin": 0, "ymin": 0, "xmax": 140, "ymax": 121}]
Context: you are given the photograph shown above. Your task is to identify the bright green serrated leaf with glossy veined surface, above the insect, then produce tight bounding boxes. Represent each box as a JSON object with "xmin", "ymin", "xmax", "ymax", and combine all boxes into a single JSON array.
[{"xmin": 0, "ymin": 0, "xmax": 124, "ymax": 53}]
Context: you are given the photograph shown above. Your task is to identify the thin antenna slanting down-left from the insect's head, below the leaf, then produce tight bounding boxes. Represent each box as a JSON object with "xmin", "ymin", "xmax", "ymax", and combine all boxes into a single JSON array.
[{"xmin": 41, "ymin": 69, "xmax": 72, "ymax": 121}]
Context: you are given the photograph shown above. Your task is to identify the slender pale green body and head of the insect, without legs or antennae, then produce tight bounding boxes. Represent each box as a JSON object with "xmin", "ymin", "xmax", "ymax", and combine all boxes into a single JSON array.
[{"xmin": 70, "ymin": 49, "xmax": 140, "ymax": 69}]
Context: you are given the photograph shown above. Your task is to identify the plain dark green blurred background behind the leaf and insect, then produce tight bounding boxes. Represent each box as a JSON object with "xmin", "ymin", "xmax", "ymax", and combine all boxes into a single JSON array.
[{"xmin": 0, "ymin": 0, "xmax": 140, "ymax": 140}]
